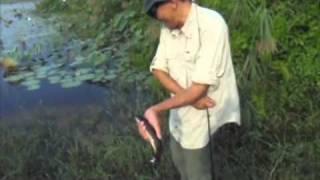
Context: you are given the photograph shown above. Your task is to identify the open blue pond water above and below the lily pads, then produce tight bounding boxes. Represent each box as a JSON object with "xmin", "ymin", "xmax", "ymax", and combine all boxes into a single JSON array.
[{"xmin": 0, "ymin": 2, "xmax": 106, "ymax": 119}]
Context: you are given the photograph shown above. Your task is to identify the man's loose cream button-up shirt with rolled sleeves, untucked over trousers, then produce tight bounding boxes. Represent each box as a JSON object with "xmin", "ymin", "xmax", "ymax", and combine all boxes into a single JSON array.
[{"xmin": 150, "ymin": 4, "xmax": 240, "ymax": 149}]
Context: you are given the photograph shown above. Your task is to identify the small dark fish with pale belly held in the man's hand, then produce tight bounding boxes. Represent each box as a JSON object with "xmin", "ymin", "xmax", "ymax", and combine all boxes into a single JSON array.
[{"xmin": 135, "ymin": 116, "xmax": 162, "ymax": 166}]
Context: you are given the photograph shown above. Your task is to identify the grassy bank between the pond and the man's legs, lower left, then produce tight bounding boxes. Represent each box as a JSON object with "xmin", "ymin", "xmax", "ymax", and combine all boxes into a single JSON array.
[{"xmin": 0, "ymin": 85, "xmax": 177, "ymax": 180}]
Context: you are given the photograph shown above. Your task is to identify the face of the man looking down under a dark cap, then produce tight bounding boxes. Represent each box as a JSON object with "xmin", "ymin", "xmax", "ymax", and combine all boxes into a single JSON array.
[{"xmin": 156, "ymin": 2, "xmax": 178, "ymax": 29}]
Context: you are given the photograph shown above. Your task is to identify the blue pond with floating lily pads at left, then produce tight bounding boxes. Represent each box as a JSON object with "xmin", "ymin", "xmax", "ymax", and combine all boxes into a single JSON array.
[{"xmin": 0, "ymin": 2, "xmax": 110, "ymax": 120}]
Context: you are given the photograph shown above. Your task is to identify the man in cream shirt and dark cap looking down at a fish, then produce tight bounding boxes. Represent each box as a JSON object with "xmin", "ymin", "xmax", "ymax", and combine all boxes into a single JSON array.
[{"xmin": 138, "ymin": 0, "xmax": 240, "ymax": 180}]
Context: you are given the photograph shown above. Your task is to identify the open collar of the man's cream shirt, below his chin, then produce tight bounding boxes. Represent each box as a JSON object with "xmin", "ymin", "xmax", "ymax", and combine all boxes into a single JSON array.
[{"xmin": 170, "ymin": 3, "xmax": 197, "ymax": 38}]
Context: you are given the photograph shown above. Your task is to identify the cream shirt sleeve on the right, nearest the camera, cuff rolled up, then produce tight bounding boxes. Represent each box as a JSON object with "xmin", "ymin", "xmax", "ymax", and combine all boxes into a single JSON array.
[{"xmin": 192, "ymin": 21, "xmax": 230, "ymax": 87}]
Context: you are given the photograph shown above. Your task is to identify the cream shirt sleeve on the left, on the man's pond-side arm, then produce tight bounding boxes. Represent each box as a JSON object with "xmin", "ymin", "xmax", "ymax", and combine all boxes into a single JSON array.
[{"xmin": 149, "ymin": 27, "xmax": 169, "ymax": 73}]
